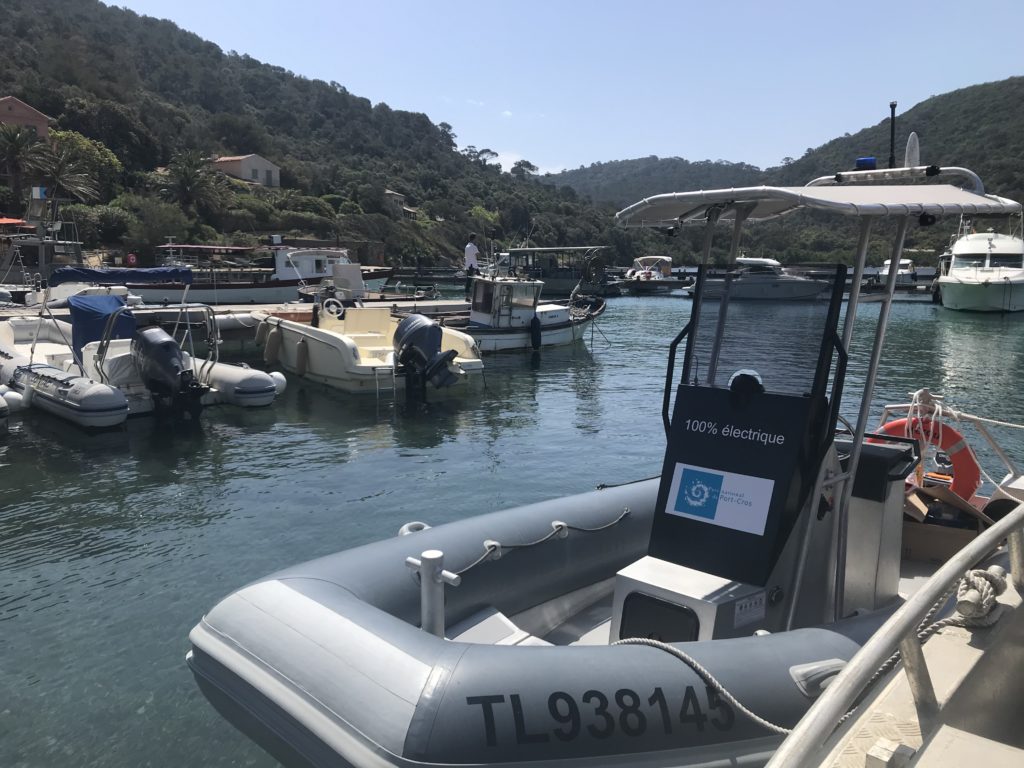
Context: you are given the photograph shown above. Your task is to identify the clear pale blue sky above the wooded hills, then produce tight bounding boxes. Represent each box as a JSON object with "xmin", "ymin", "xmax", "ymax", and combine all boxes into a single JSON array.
[{"xmin": 111, "ymin": 0, "xmax": 1024, "ymax": 171}]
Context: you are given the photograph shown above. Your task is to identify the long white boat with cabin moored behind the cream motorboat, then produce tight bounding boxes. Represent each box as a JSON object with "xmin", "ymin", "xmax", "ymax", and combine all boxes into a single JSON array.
[{"xmin": 128, "ymin": 245, "xmax": 389, "ymax": 305}]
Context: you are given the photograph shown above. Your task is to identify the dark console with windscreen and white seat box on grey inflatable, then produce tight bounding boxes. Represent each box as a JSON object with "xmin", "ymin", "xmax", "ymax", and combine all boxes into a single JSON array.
[{"xmin": 611, "ymin": 266, "xmax": 915, "ymax": 642}]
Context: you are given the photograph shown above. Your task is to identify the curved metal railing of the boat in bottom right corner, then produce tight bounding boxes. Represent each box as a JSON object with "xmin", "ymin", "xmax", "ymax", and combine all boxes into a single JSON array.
[{"xmin": 766, "ymin": 495, "xmax": 1024, "ymax": 768}]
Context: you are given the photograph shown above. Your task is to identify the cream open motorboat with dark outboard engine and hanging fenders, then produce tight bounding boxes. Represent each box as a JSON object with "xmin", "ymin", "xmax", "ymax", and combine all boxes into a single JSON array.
[{"xmin": 252, "ymin": 306, "xmax": 483, "ymax": 395}]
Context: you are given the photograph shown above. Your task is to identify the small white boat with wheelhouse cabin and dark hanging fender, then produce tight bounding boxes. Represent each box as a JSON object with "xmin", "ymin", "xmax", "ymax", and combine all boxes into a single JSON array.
[{"xmin": 443, "ymin": 275, "xmax": 605, "ymax": 352}]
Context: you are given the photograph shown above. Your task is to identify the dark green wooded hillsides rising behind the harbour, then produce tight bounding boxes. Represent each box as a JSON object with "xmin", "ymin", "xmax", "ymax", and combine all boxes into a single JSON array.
[{"xmin": 0, "ymin": 0, "xmax": 1024, "ymax": 264}]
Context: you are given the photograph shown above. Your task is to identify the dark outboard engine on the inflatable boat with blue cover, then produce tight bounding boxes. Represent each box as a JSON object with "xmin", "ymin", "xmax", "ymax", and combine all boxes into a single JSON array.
[{"xmin": 131, "ymin": 326, "xmax": 210, "ymax": 418}]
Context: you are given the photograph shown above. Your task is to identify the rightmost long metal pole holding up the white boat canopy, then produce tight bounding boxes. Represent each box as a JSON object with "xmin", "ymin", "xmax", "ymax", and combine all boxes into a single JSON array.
[{"xmin": 835, "ymin": 216, "xmax": 910, "ymax": 622}]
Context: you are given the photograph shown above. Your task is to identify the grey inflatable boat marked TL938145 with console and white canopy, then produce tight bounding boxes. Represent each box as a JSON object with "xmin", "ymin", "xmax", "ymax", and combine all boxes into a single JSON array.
[{"xmin": 188, "ymin": 159, "xmax": 1020, "ymax": 768}]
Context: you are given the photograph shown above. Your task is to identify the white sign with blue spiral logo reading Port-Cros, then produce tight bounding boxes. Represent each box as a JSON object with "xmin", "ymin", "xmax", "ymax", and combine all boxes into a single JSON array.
[{"xmin": 667, "ymin": 464, "xmax": 775, "ymax": 536}]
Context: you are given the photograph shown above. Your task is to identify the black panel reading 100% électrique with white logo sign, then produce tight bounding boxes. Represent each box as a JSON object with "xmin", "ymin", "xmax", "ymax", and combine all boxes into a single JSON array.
[{"xmin": 648, "ymin": 384, "xmax": 825, "ymax": 586}]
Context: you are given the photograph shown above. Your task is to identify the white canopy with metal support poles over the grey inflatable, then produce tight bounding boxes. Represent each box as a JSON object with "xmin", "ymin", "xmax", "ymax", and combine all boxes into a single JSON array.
[{"xmin": 615, "ymin": 166, "xmax": 1021, "ymax": 620}]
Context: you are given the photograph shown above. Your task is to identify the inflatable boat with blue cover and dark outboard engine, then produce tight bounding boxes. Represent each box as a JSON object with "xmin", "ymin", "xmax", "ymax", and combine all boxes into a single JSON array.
[{"xmin": 0, "ymin": 296, "xmax": 285, "ymax": 428}]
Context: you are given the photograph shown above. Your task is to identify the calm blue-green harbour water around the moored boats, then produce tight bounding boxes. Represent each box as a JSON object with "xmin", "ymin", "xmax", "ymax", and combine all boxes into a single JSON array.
[{"xmin": 0, "ymin": 297, "xmax": 1024, "ymax": 768}]
